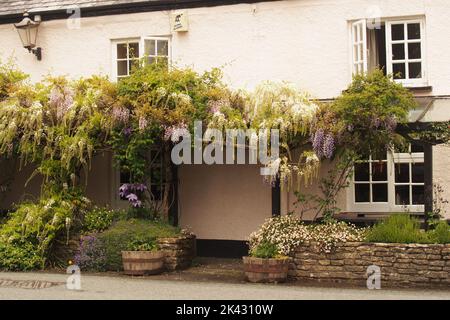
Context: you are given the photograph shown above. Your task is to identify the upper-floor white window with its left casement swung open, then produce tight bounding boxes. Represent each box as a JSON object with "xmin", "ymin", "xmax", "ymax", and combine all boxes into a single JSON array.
[{"xmin": 351, "ymin": 19, "xmax": 428, "ymax": 87}]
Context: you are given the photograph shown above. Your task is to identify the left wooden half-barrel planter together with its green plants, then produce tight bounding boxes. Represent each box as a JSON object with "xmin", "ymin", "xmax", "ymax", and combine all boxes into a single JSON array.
[{"xmin": 122, "ymin": 239, "xmax": 164, "ymax": 276}]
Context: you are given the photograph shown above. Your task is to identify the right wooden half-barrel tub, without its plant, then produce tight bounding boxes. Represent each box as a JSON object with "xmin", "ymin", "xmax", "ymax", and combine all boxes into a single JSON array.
[{"xmin": 243, "ymin": 257, "xmax": 292, "ymax": 283}]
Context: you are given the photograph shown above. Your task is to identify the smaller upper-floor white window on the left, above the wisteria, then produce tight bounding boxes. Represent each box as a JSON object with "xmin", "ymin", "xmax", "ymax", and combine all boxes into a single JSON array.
[{"xmin": 112, "ymin": 37, "xmax": 170, "ymax": 80}]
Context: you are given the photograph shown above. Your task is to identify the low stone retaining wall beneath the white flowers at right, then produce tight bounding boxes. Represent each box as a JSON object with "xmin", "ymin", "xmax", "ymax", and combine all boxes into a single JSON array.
[{"xmin": 289, "ymin": 242, "xmax": 450, "ymax": 288}]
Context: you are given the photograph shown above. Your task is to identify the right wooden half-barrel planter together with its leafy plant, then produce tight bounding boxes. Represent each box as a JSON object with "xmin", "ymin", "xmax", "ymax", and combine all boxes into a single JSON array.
[{"xmin": 243, "ymin": 241, "xmax": 291, "ymax": 283}]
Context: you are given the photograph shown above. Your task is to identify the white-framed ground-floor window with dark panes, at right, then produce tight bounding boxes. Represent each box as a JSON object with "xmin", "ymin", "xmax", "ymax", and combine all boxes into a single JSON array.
[{"xmin": 348, "ymin": 145, "xmax": 425, "ymax": 212}]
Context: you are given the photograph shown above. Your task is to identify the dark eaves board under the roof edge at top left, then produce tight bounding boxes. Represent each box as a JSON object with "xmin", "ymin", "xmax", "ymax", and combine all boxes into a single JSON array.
[{"xmin": 0, "ymin": 0, "xmax": 282, "ymax": 25}]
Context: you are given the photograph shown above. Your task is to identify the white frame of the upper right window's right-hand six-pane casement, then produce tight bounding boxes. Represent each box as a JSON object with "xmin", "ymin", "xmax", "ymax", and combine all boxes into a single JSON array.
[{"xmin": 386, "ymin": 18, "xmax": 428, "ymax": 87}]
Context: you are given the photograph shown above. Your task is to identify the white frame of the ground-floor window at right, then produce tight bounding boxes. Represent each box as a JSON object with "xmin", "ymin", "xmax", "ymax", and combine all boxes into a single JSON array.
[{"xmin": 347, "ymin": 151, "xmax": 425, "ymax": 213}]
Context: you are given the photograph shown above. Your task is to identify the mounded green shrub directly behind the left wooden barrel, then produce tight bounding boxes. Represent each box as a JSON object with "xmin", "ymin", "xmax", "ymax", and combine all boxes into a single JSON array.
[{"xmin": 97, "ymin": 219, "xmax": 179, "ymax": 271}]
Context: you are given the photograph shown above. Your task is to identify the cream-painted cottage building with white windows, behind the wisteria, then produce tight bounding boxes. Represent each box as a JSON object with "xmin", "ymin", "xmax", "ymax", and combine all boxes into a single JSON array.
[{"xmin": 0, "ymin": 0, "xmax": 450, "ymax": 253}]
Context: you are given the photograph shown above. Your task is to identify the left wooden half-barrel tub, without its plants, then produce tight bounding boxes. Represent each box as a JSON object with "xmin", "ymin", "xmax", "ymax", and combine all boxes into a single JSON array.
[{"xmin": 122, "ymin": 251, "xmax": 165, "ymax": 276}]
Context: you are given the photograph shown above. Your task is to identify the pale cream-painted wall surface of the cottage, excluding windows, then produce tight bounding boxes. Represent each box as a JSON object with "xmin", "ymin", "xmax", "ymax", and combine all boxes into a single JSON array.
[{"xmin": 0, "ymin": 0, "xmax": 450, "ymax": 239}]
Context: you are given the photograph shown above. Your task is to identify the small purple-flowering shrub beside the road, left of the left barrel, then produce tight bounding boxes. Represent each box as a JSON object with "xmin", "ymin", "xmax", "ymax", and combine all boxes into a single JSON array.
[{"xmin": 74, "ymin": 235, "xmax": 106, "ymax": 271}]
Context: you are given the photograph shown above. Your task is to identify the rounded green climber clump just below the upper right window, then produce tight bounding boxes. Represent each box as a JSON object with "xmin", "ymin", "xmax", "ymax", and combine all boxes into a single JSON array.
[{"xmin": 333, "ymin": 70, "xmax": 417, "ymax": 156}]
